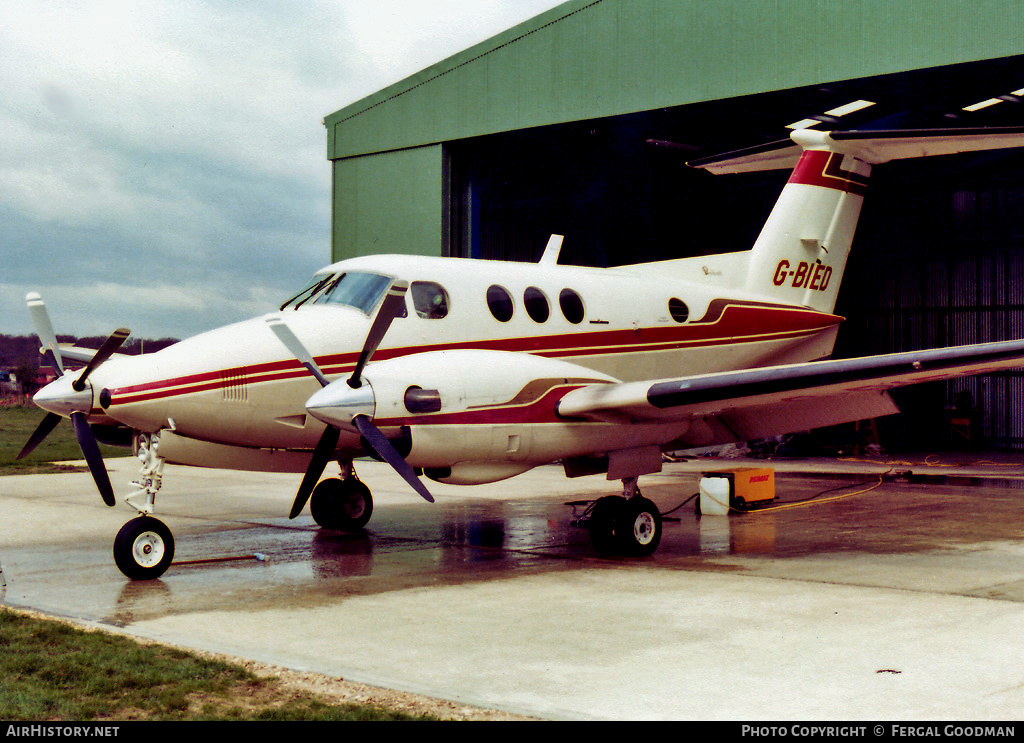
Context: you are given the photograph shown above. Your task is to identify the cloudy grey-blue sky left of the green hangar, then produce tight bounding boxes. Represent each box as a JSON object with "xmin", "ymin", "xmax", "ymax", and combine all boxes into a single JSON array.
[{"xmin": 0, "ymin": 0, "xmax": 562, "ymax": 338}]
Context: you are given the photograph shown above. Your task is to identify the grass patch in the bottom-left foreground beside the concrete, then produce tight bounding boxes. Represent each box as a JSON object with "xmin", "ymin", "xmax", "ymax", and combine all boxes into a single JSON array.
[{"xmin": 0, "ymin": 608, "xmax": 435, "ymax": 722}]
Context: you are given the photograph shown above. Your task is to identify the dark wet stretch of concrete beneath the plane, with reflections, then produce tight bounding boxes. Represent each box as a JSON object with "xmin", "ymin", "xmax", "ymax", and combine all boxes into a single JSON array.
[{"xmin": 75, "ymin": 476, "xmax": 1024, "ymax": 624}]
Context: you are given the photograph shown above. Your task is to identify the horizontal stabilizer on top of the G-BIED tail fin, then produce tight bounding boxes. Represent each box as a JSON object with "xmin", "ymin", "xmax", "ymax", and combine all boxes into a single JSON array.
[{"xmin": 687, "ymin": 127, "xmax": 1024, "ymax": 174}]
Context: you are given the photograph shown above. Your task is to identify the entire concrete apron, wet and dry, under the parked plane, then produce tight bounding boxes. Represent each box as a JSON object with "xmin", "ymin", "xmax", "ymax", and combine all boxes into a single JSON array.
[{"xmin": 0, "ymin": 462, "xmax": 1024, "ymax": 719}]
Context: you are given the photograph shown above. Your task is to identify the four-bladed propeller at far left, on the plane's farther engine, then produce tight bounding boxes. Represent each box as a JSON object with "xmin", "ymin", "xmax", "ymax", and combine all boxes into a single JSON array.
[{"xmin": 17, "ymin": 292, "xmax": 131, "ymax": 506}]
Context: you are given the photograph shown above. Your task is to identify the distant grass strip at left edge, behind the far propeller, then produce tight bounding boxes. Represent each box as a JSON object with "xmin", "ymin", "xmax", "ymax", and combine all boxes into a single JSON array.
[{"xmin": 0, "ymin": 405, "xmax": 124, "ymax": 475}]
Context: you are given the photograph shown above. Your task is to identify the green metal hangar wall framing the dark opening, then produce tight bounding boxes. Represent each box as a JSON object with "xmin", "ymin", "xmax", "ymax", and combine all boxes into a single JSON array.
[{"xmin": 325, "ymin": 0, "xmax": 1024, "ymax": 259}]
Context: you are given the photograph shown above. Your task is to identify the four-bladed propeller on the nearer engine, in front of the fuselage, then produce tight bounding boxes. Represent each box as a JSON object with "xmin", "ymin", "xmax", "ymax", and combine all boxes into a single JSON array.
[{"xmin": 267, "ymin": 281, "xmax": 434, "ymax": 519}]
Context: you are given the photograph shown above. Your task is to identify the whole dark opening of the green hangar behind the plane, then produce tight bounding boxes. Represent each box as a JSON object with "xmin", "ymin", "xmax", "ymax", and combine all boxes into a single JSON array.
[{"xmin": 446, "ymin": 56, "xmax": 1024, "ymax": 448}]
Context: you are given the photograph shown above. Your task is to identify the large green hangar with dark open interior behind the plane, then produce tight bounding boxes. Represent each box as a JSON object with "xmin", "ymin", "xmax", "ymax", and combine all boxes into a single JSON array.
[{"xmin": 325, "ymin": 0, "xmax": 1024, "ymax": 449}]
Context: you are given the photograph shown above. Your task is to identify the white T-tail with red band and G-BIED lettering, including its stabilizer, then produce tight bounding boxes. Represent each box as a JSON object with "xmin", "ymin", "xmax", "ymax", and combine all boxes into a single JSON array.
[{"xmin": 690, "ymin": 127, "xmax": 1024, "ymax": 312}]
